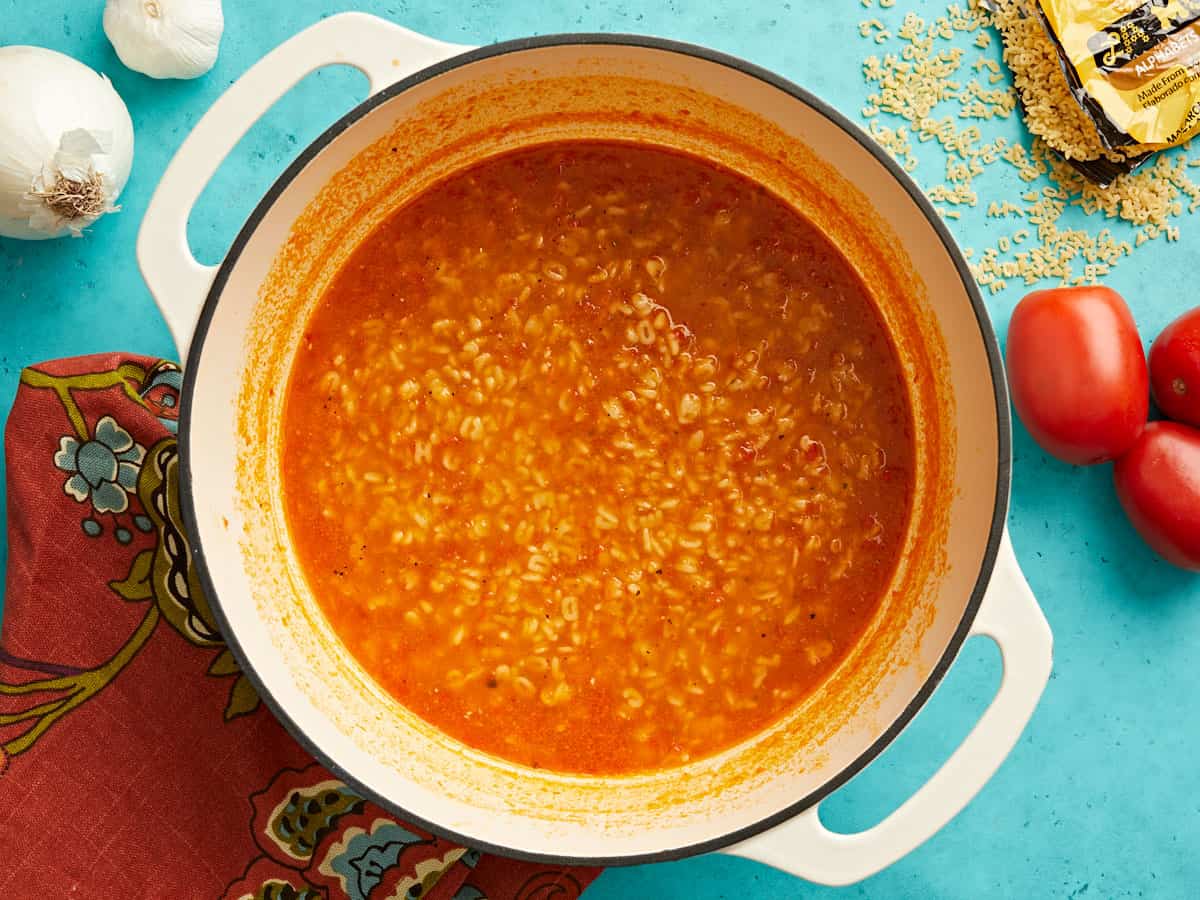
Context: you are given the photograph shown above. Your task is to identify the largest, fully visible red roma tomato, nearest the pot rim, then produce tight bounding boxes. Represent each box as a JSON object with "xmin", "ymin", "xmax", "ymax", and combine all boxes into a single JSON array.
[{"xmin": 1007, "ymin": 287, "xmax": 1150, "ymax": 466}]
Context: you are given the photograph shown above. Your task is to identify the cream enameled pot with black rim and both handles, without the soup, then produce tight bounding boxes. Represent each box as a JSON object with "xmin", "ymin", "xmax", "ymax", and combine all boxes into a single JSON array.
[{"xmin": 138, "ymin": 13, "xmax": 1051, "ymax": 884}]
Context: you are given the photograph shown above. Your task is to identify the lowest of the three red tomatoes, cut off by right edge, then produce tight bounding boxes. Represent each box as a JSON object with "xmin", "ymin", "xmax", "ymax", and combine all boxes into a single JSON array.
[{"xmin": 1112, "ymin": 422, "xmax": 1200, "ymax": 571}]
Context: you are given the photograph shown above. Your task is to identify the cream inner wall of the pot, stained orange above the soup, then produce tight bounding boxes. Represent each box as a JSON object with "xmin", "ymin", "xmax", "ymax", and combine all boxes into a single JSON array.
[{"xmin": 190, "ymin": 44, "xmax": 997, "ymax": 859}]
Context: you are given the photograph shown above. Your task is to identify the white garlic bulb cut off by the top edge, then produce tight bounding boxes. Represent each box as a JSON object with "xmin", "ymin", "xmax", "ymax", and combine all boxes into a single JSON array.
[{"xmin": 104, "ymin": 0, "xmax": 224, "ymax": 78}]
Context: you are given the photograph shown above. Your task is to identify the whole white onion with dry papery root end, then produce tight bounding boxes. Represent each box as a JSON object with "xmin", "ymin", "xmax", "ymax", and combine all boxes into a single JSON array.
[{"xmin": 0, "ymin": 46, "xmax": 133, "ymax": 240}]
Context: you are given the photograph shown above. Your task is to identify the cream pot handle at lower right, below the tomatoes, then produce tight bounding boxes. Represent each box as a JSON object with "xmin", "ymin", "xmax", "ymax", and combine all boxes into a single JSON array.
[{"xmin": 722, "ymin": 530, "xmax": 1052, "ymax": 886}]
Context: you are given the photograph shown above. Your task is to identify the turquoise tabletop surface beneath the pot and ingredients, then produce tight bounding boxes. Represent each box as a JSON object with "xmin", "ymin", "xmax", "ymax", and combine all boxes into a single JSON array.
[{"xmin": 0, "ymin": 0, "xmax": 1200, "ymax": 900}]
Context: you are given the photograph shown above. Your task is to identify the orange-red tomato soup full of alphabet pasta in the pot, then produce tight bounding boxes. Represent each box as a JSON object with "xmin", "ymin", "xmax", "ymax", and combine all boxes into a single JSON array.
[{"xmin": 281, "ymin": 142, "xmax": 914, "ymax": 774}]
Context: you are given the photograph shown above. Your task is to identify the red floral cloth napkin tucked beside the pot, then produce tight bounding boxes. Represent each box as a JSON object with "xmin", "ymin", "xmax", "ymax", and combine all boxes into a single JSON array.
[{"xmin": 0, "ymin": 354, "xmax": 599, "ymax": 900}]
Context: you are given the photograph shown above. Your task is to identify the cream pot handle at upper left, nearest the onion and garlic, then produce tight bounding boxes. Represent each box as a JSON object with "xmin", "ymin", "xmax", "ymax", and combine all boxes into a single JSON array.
[{"xmin": 137, "ymin": 12, "xmax": 469, "ymax": 361}]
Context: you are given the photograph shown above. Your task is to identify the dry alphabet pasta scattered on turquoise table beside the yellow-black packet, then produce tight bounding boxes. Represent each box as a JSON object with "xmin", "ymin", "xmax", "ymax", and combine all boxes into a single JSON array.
[{"xmin": 862, "ymin": 0, "xmax": 1200, "ymax": 286}]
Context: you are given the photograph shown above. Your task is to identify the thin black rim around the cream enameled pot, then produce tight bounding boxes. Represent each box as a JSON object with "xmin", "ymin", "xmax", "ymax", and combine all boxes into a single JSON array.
[{"xmin": 179, "ymin": 32, "xmax": 1012, "ymax": 866}]
